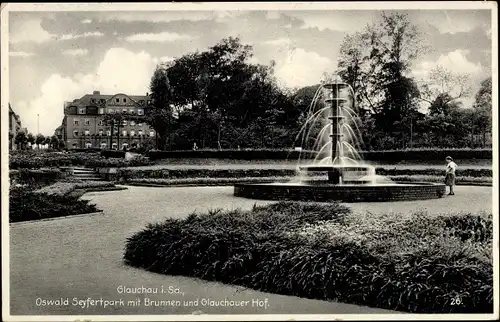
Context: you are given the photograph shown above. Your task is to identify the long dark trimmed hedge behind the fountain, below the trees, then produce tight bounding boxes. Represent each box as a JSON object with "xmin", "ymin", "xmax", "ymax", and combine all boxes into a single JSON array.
[{"xmin": 147, "ymin": 149, "xmax": 492, "ymax": 162}]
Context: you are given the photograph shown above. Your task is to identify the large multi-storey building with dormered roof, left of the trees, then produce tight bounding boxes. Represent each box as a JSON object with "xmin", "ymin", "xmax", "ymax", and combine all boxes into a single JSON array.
[{"xmin": 55, "ymin": 91, "xmax": 155, "ymax": 150}]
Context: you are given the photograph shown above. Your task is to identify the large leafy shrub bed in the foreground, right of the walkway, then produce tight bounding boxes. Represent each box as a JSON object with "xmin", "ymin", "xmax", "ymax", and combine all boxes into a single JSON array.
[{"xmin": 124, "ymin": 202, "xmax": 493, "ymax": 313}]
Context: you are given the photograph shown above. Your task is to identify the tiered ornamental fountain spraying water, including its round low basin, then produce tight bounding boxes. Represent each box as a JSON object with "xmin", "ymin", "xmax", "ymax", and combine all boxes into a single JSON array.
[{"xmin": 234, "ymin": 81, "xmax": 446, "ymax": 202}]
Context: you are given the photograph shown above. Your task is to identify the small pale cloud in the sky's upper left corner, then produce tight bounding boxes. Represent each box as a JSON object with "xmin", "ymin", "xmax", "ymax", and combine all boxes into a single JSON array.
[{"xmin": 9, "ymin": 19, "xmax": 53, "ymax": 44}]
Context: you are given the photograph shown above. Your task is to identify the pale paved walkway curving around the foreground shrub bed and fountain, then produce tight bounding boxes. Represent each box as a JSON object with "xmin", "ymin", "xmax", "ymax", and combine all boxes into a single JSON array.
[{"xmin": 10, "ymin": 187, "xmax": 492, "ymax": 315}]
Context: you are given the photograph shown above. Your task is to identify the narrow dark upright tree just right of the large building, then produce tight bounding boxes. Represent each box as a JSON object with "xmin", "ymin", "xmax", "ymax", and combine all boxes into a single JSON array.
[{"xmin": 146, "ymin": 66, "xmax": 175, "ymax": 150}]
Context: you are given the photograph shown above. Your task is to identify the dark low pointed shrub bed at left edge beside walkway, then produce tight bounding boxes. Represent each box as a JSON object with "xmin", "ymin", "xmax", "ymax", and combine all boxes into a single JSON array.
[{"xmin": 9, "ymin": 188, "xmax": 98, "ymax": 222}]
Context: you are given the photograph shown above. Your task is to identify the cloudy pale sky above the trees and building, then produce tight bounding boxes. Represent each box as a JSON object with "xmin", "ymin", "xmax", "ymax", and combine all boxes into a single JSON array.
[{"xmin": 8, "ymin": 4, "xmax": 492, "ymax": 135}]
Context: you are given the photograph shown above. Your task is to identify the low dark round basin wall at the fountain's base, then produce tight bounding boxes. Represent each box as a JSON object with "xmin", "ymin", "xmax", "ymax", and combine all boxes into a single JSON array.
[{"xmin": 234, "ymin": 182, "xmax": 446, "ymax": 202}]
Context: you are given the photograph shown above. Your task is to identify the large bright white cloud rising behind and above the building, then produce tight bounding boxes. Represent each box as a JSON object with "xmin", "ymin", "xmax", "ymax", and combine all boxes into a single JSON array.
[{"xmin": 15, "ymin": 48, "xmax": 160, "ymax": 135}]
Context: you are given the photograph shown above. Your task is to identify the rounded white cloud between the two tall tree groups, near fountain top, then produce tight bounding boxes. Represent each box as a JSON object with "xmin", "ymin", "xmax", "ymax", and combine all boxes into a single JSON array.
[{"xmin": 276, "ymin": 48, "xmax": 334, "ymax": 88}]
